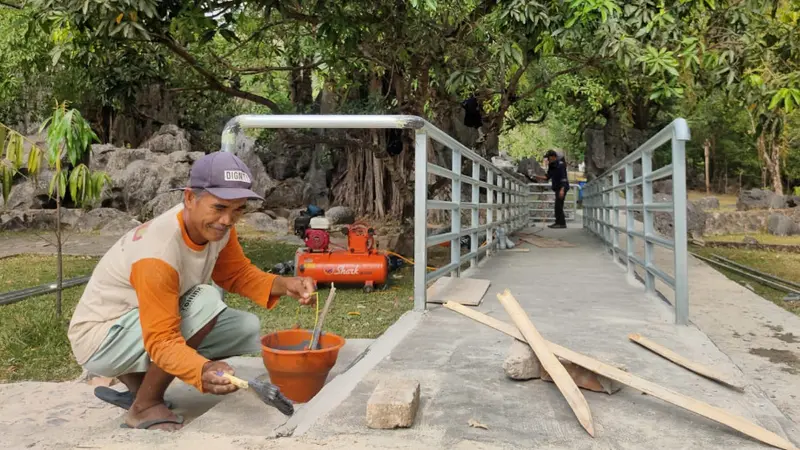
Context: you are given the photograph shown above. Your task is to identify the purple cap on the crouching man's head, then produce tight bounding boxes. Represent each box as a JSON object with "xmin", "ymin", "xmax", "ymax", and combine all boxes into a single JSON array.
[{"xmin": 175, "ymin": 152, "xmax": 264, "ymax": 200}]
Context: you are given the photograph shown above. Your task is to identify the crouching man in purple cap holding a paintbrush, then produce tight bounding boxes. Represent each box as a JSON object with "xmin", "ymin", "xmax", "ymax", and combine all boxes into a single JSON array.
[{"xmin": 68, "ymin": 152, "xmax": 315, "ymax": 430}]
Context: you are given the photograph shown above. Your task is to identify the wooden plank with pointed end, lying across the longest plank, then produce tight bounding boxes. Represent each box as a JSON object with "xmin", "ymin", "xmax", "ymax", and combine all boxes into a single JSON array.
[{"xmin": 497, "ymin": 289, "xmax": 594, "ymax": 437}]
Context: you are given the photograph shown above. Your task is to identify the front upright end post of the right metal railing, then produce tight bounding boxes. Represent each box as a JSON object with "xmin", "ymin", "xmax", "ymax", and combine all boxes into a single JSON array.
[{"xmin": 672, "ymin": 136, "xmax": 689, "ymax": 325}]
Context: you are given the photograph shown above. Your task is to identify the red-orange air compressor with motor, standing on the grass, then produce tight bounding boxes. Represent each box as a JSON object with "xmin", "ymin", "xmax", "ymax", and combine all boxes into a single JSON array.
[{"xmin": 294, "ymin": 217, "xmax": 389, "ymax": 293}]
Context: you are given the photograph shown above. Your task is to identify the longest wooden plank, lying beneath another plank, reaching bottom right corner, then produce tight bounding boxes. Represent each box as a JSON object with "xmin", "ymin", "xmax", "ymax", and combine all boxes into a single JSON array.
[{"xmin": 444, "ymin": 302, "xmax": 797, "ymax": 450}]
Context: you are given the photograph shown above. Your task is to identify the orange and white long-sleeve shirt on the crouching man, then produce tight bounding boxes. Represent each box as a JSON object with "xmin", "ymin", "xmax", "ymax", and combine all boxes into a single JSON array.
[{"xmin": 67, "ymin": 204, "xmax": 278, "ymax": 392}]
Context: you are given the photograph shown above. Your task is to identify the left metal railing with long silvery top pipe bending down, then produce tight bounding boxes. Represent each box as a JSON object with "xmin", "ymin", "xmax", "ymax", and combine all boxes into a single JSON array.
[{"xmin": 221, "ymin": 115, "xmax": 528, "ymax": 310}]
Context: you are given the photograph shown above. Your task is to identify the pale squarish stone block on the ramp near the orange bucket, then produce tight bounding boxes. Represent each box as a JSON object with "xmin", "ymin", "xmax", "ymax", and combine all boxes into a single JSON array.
[{"xmin": 367, "ymin": 379, "xmax": 419, "ymax": 429}]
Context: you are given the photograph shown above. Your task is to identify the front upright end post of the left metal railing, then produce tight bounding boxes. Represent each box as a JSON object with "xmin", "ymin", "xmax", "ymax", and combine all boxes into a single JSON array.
[{"xmin": 414, "ymin": 130, "xmax": 428, "ymax": 311}]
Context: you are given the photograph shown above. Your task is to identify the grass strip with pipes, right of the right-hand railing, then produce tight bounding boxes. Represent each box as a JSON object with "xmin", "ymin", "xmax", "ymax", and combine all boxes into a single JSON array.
[{"xmin": 691, "ymin": 246, "xmax": 800, "ymax": 315}]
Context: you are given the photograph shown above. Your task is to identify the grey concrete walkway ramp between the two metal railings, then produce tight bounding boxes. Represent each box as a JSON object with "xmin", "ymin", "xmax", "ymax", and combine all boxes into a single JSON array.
[{"xmin": 307, "ymin": 229, "xmax": 792, "ymax": 449}]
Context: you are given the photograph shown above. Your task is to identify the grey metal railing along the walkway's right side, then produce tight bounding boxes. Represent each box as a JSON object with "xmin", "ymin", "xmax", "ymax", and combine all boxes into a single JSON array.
[{"xmin": 583, "ymin": 118, "xmax": 690, "ymax": 325}]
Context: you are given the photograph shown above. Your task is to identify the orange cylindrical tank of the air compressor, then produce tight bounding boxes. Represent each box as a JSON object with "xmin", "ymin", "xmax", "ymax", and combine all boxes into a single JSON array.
[{"xmin": 295, "ymin": 248, "xmax": 389, "ymax": 286}]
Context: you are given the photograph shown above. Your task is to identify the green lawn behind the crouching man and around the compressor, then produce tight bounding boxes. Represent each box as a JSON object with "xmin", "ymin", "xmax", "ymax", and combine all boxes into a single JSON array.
[{"xmin": 0, "ymin": 239, "xmax": 414, "ymax": 382}]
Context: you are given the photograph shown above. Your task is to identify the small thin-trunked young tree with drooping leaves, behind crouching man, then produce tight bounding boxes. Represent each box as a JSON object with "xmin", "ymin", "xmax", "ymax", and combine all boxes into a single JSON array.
[{"xmin": 35, "ymin": 103, "xmax": 111, "ymax": 318}]
